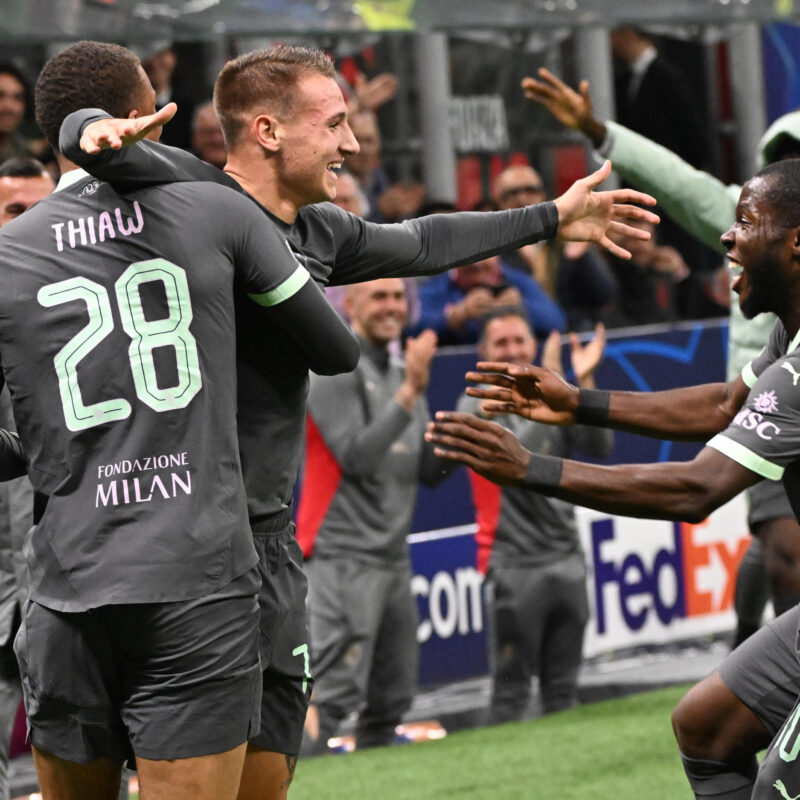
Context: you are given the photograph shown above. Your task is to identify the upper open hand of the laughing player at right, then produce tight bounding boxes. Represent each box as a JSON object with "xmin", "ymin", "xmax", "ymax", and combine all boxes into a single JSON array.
[{"xmin": 466, "ymin": 361, "xmax": 578, "ymax": 425}]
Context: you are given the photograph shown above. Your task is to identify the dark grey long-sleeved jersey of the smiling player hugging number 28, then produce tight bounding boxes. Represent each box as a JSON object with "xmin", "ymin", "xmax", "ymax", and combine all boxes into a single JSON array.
[{"xmin": 61, "ymin": 109, "xmax": 558, "ymax": 530}]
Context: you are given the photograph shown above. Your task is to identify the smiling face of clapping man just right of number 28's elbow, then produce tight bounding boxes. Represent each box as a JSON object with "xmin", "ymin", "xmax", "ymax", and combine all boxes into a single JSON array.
[{"xmin": 345, "ymin": 278, "xmax": 408, "ymax": 347}]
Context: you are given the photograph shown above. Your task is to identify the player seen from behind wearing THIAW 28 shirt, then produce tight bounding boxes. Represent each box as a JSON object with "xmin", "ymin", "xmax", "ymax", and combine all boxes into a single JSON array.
[{"xmin": 5, "ymin": 42, "xmax": 358, "ymax": 800}]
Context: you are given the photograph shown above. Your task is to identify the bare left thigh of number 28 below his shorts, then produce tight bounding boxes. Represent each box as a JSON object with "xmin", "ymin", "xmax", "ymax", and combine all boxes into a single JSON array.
[{"xmin": 33, "ymin": 747, "xmax": 122, "ymax": 800}]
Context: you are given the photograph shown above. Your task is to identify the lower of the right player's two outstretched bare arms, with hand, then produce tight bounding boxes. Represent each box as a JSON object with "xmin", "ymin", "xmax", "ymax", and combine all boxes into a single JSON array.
[{"xmin": 426, "ymin": 412, "xmax": 761, "ymax": 522}]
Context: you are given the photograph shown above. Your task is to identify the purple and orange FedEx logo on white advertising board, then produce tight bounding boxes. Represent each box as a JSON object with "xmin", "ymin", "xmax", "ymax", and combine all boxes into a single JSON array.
[{"xmin": 591, "ymin": 519, "xmax": 748, "ymax": 634}]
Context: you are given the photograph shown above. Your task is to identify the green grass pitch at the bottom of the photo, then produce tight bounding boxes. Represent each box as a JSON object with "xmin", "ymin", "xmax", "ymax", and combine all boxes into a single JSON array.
[{"xmin": 289, "ymin": 686, "xmax": 692, "ymax": 800}]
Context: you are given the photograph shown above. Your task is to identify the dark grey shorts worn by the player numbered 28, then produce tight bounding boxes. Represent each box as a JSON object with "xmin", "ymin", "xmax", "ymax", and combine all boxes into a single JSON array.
[{"xmin": 15, "ymin": 569, "xmax": 261, "ymax": 763}]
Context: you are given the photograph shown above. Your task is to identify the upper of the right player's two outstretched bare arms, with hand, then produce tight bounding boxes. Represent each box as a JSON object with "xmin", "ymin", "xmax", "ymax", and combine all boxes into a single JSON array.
[{"xmin": 467, "ymin": 361, "xmax": 748, "ymax": 441}]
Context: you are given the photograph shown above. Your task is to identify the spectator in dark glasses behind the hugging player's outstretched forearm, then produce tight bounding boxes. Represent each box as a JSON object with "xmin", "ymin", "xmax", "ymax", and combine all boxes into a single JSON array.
[{"xmin": 493, "ymin": 164, "xmax": 616, "ymax": 330}]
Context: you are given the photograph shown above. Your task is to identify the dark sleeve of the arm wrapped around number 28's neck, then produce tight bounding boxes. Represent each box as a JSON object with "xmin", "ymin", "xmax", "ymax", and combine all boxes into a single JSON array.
[{"xmin": 59, "ymin": 108, "xmax": 242, "ymax": 191}]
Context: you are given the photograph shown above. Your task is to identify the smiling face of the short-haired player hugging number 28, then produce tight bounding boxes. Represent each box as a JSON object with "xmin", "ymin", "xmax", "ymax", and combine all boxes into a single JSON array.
[{"xmin": 276, "ymin": 74, "xmax": 358, "ymax": 208}]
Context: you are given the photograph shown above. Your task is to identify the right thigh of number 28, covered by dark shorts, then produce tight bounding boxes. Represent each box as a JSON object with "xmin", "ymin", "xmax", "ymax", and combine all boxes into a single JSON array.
[{"xmin": 119, "ymin": 570, "xmax": 261, "ymax": 761}]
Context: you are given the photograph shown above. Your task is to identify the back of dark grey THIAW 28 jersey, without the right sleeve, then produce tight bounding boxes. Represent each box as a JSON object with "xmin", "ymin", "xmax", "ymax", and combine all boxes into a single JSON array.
[{"xmin": 0, "ymin": 173, "xmax": 255, "ymax": 610}]
